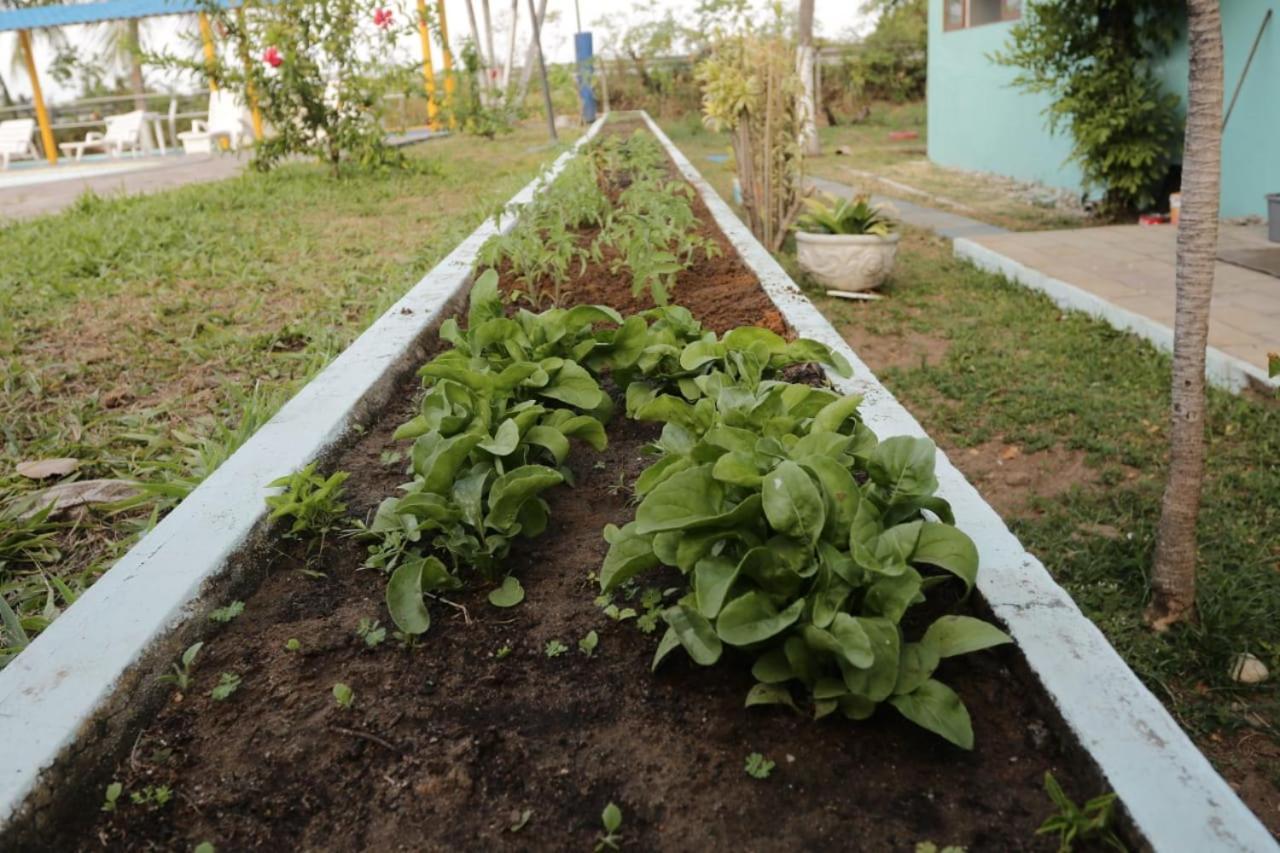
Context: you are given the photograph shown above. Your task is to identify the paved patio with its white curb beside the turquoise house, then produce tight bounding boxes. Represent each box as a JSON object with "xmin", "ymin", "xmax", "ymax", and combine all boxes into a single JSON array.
[{"xmin": 812, "ymin": 178, "xmax": 1280, "ymax": 391}]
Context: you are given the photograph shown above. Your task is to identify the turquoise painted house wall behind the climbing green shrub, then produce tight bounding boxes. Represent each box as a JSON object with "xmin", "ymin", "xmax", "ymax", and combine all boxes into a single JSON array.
[{"xmin": 928, "ymin": 0, "xmax": 1280, "ymax": 218}]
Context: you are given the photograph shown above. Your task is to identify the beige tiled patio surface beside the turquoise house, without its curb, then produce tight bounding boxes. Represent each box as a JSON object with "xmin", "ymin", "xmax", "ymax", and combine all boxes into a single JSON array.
[{"xmin": 970, "ymin": 225, "xmax": 1280, "ymax": 370}]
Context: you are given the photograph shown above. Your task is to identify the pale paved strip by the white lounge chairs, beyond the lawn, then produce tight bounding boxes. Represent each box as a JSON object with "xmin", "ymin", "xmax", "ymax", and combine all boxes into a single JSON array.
[{"xmin": 0, "ymin": 152, "xmax": 250, "ymax": 223}]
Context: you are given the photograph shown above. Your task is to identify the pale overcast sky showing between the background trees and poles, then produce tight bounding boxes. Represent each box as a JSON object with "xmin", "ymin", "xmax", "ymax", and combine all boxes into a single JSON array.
[{"xmin": 0, "ymin": 0, "xmax": 869, "ymax": 101}]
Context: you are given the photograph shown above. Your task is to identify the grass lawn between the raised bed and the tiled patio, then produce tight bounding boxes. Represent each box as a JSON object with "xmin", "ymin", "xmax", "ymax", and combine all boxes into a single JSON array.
[{"xmin": 672, "ymin": 126, "xmax": 1280, "ymax": 833}]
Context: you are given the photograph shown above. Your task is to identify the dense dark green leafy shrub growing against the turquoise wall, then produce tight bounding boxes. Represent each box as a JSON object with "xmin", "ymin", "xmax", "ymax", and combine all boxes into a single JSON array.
[{"xmin": 992, "ymin": 0, "xmax": 1183, "ymax": 216}]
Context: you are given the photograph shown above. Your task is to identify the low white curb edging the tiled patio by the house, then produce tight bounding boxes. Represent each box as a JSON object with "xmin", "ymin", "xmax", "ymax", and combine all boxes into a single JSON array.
[{"xmin": 954, "ymin": 237, "xmax": 1280, "ymax": 393}]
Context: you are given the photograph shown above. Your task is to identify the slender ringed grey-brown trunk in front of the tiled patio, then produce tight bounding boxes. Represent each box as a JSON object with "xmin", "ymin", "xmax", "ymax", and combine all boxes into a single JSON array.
[{"xmin": 1147, "ymin": 0, "xmax": 1222, "ymax": 631}]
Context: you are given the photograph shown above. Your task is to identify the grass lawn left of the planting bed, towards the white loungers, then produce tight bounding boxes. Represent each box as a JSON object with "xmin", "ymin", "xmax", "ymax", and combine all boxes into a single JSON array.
[{"xmin": 0, "ymin": 126, "xmax": 578, "ymax": 653}]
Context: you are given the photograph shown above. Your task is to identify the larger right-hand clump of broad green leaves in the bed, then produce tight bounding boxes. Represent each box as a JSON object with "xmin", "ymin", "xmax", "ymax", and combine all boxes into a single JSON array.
[{"xmin": 600, "ymin": 328, "xmax": 1009, "ymax": 749}]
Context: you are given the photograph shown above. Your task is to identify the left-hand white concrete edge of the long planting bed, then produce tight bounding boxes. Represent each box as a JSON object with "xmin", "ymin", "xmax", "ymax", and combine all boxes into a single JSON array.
[{"xmin": 0, "ymin": 118, "xmax": 603, "ymax": 830}]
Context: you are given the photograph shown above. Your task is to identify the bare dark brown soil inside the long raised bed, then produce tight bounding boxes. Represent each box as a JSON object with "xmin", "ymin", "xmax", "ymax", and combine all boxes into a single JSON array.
[{"xmin": 41, "ymin": 121, "xmax": 1101, "ymax": 850}]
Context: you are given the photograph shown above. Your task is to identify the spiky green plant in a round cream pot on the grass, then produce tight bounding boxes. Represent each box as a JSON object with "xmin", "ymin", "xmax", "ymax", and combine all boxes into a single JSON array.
[{"xmin": 795, "ymin": 196, "xmax": 900, "ymax": 292}]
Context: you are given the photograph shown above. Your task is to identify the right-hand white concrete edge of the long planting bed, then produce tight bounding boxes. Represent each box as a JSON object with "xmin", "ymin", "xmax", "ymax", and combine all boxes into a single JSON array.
[{"xmin": 645, "ymin": 115, "xmax": 1280, "ymax": 853}]
